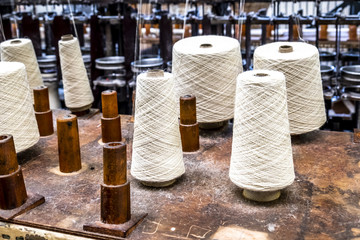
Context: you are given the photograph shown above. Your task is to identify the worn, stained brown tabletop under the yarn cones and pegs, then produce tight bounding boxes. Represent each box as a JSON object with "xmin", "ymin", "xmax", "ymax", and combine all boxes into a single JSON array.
[{"xmin": 0, "ymin": 109, "xmax": 360, "ymax": 239}]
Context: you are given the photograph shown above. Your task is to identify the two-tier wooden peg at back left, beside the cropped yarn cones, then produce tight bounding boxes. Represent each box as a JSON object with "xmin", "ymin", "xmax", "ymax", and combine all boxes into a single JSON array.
[{"xmin": 33, "ymin": 86, "xmax": 54, "ymax": 137}]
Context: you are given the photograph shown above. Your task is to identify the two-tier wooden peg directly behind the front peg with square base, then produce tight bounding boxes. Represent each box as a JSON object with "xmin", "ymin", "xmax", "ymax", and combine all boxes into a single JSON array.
[{"xmin": 101, "ymin": 90, "xmax": 122, "ymax": 143}]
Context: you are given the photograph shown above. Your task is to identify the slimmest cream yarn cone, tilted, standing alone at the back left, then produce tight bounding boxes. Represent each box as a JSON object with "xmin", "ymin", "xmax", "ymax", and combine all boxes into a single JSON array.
[{"xmin": 59, "ymin": 35, "xmax": 94, "ymax": 112}]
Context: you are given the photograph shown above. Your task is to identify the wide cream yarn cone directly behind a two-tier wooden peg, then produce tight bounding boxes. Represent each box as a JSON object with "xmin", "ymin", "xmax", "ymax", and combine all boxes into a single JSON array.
[{"xmin": 172, "ymin": 36, "xmax": 242, "ymax": 123}]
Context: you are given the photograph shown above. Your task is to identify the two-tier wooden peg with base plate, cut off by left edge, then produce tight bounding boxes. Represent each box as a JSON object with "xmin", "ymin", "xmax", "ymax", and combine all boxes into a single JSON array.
[{"xmin": 0, "ymin": 135, "xmax": 45, "ymax": 220}]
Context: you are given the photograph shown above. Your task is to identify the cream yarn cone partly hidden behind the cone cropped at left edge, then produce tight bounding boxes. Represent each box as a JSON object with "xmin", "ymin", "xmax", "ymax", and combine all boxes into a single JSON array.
[{"xmin": 1, "ymin": 38, "xmax": 44, "ymax": 101}]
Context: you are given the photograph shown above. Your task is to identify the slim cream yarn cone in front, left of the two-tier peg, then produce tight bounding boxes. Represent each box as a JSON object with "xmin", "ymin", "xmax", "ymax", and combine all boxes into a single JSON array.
[{"xmin": 131, "ymin": 70, "xmax": 185, "ymax": 186}]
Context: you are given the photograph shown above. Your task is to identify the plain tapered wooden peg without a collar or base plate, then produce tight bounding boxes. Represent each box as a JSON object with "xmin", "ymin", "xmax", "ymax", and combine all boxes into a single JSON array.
[{"xmin": 56, "ymin": 114, "xmax": 81, "ymax": 173}]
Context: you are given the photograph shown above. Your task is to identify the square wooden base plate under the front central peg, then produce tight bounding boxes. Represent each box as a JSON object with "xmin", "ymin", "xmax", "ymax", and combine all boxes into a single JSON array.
[{"xmin": 83, "ymin": 213, "xmax": 148, "ymax": 238}]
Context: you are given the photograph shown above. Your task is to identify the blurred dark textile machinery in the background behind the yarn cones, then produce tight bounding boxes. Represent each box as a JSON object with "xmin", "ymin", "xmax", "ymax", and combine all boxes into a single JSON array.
[{"xmin": 0, "ymin": 0, "xmax": 360, "ymax": 131}]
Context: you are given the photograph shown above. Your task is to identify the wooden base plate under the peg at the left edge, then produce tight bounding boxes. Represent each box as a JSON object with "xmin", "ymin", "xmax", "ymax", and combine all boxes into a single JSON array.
[{"xmin": 0, "ymin": 193, "xmax": 45, "ymax": 220}]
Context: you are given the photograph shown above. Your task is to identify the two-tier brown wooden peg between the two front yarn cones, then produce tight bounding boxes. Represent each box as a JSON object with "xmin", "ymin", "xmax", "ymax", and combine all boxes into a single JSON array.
[{"xmin": 180, "ymin": 95, "xmax": 200, "ymax": 152}]
